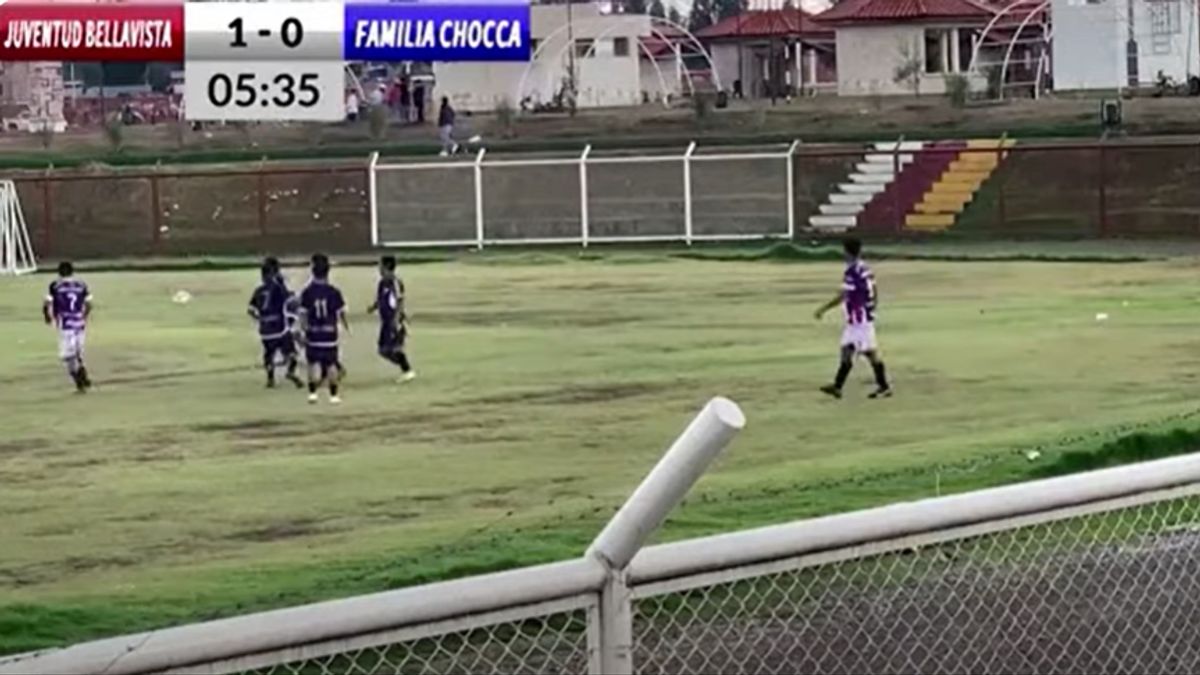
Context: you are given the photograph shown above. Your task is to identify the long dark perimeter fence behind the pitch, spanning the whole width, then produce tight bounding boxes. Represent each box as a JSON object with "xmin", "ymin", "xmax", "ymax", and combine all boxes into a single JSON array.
[{"xmin": 11, "ymin": 141, "xmax": 1200, "ymax": 258}]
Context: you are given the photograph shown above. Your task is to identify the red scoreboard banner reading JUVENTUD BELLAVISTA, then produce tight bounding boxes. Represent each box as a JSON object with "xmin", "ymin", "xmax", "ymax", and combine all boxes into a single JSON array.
[{"xmin": 0, "ymin": 0, "xmax": 184, "ymax": 61}]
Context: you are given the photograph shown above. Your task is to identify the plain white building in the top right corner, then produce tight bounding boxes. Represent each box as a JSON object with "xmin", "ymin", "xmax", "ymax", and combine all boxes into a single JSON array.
[{"xmin": 1051, "ymin": 0, "xmax": 1200, "ymax": 91}]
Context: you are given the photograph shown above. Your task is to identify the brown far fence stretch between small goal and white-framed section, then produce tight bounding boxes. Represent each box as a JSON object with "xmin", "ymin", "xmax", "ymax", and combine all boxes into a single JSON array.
[{"xmin": 12, "ymin": 162, "xmax": 370, "ymax": 258}]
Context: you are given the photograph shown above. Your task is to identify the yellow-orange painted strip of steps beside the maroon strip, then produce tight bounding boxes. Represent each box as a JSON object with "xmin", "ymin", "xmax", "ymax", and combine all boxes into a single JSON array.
[{"xmin": 905, "ymin": 138, "xmax": 1013, "ymax": 232}]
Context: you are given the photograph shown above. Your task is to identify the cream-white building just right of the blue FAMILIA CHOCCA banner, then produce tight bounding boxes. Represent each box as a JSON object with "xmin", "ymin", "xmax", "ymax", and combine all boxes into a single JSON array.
[{"xmin": 433, "ymin": 4, "xmax": 684, "ymax": 112}]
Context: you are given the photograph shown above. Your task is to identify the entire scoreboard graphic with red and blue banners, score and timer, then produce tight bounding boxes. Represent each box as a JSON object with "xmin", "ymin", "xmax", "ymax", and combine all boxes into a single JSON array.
[{"xmin": 0, "ymin": 0, "xmax": 532, "ymax": 121}]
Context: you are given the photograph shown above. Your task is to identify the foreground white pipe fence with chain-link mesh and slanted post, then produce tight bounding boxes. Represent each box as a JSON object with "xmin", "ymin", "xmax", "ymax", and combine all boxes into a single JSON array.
[{"xmin": 7, "ymin": 399, "xmax": 1200, "ymax": 675}]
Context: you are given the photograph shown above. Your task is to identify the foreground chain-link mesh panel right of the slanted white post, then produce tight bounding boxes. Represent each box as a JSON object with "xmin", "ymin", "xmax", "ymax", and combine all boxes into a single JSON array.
[{"xmin": 634, "ymin": 489, "xmax": 1200, "ymax": 674}]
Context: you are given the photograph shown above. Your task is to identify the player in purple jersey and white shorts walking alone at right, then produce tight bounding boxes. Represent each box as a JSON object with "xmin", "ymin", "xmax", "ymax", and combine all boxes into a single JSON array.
[{"xmin": 816, "ymin": 239, "xmax": 892, "ymax": 399}]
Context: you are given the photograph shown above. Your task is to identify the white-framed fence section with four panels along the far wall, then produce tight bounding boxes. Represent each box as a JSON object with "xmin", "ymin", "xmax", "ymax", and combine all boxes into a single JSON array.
[{"xmin": 368, "ymin": 142, "xmax": 799, "ymax": 249}]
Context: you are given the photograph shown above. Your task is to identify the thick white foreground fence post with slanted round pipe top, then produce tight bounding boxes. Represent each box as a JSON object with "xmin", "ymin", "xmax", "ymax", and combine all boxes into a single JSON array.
[{"xmin": 586, "ymin": 398, "xmax": 745, "ymax": 675}]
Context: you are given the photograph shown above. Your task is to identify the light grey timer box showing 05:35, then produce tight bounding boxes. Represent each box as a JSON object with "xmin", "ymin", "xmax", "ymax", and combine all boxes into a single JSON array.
[{"xmin": 184, "ymin": 61, "xmax": 346, "ymax": 121}]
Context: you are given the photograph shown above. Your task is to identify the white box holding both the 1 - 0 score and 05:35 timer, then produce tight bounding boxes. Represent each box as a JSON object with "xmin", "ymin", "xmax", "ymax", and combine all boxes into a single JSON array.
[{"xmin": 184, "ymin": 2, "xmax": 346, "ymax": 121}]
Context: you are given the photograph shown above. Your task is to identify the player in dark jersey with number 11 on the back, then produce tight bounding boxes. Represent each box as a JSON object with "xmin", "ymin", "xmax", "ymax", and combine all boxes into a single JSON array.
[{"xmin": 300, "ymin": 253, "xmax": 350, "ymax": 405}]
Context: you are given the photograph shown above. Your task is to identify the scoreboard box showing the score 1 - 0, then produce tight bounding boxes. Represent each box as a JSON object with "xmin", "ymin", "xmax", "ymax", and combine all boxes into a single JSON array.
[{"xmin": 184, "ymin": 2, "xmax": 346, "ymax": 60}]
